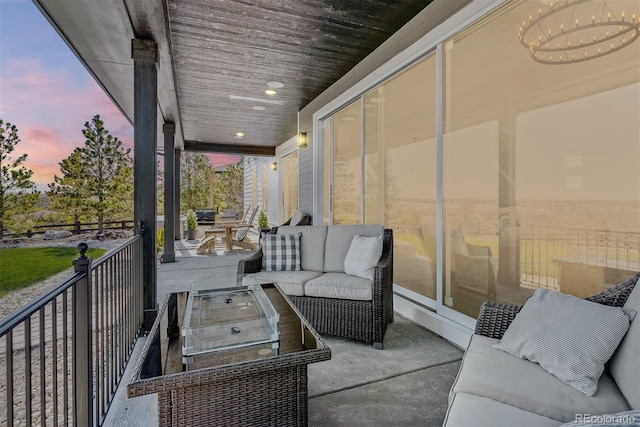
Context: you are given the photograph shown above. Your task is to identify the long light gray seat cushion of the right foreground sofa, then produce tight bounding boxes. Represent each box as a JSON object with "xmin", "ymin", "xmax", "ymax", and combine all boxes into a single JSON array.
[{"xmin": 452, "ymin": 335, "xmax": 630, "ymax": 422}]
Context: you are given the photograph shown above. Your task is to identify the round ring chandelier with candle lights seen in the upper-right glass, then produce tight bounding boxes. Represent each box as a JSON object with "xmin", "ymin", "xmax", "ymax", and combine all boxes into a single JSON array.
[{"xmin": 518, "ymin": 0, "xmax": 640, "ymax": 64}]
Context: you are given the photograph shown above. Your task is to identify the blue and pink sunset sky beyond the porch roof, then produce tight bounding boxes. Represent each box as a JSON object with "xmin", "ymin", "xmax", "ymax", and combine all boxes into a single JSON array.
[{"xmin": 0, "ymin": 0, "xmax": 238, "ymax": 190}]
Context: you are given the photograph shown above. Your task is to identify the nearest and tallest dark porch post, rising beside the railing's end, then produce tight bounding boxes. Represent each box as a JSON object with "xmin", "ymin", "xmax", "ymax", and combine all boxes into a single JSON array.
[{"xmin": 131, "ymin": 39, "xmax": 158, "ymax": 331}]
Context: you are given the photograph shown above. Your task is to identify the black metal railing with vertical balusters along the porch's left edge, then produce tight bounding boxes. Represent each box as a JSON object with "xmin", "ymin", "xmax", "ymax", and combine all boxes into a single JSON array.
[{"xmin": 0, "ymin": 235, "xmax": 143, "ymax": 426}]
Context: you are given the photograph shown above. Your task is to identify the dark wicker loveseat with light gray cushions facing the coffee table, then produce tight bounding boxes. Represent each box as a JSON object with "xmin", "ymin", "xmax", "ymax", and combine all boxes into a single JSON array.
[{"xmin": 238, "ymin": 224, "xmax": 393, "ymax": 349}]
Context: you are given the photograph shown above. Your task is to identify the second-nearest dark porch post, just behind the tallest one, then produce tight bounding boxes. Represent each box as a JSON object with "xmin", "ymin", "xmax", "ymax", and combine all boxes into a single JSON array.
[{"xmin": 162, "ymin": 123, "xmax": 176, "ymax": 262}]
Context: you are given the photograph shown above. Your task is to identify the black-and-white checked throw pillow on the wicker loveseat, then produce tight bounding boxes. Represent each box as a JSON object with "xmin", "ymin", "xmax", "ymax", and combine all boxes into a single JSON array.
[{"xmin": 262, "ymin": 233, "xmax": 302, "ymax": 271}]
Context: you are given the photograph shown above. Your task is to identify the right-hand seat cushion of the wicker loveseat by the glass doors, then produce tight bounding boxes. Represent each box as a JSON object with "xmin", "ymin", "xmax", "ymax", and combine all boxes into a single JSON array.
[{"xmin": 304, "ymin": 273, "xmax": 373, "ymax": 301}]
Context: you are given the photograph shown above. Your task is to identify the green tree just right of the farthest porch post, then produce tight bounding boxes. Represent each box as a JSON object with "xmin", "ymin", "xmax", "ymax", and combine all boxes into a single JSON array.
[{"xmin": 180, "ymin": 152, "xmax": 214, "ymax": 213}]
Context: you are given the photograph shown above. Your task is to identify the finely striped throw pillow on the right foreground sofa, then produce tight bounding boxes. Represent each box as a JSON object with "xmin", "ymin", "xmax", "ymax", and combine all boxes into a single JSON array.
[{"xmin": 493, "ymin": 289, "xmax": 635, "ymax": 396}]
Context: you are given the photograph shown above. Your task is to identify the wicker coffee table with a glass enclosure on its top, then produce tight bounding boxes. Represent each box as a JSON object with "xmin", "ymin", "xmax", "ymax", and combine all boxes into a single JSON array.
[{"xmin": 127, "ymin": 284, "xmax": 331, "ymax": 426}]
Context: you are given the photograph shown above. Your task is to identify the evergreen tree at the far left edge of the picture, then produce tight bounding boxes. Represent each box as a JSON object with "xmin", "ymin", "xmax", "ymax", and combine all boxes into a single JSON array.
[{"xmin": 0, "ymin": 119, "xmax": 39, "ymax": 238}]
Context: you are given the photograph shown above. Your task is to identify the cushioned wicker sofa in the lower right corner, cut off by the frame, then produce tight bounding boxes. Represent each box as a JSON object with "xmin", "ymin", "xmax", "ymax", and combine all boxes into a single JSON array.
[{"xmin": 444, "ymin": 273, "xmax": 640, "ymax": 427}]
